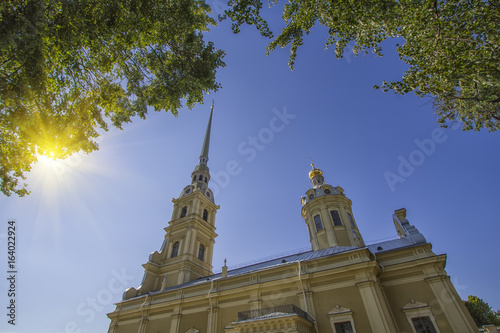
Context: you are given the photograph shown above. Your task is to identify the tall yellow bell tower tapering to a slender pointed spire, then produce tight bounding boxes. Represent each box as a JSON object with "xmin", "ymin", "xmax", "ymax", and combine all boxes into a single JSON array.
[{"xmin": 124, "ymin": 104, "xmax": 219, "ymax": 299}]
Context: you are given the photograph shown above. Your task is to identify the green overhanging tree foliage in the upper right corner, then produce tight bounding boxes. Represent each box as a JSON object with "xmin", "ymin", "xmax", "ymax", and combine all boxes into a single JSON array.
[{"xmin": 221, "ymin": 0, "xmax": 500, "ymax": 132}]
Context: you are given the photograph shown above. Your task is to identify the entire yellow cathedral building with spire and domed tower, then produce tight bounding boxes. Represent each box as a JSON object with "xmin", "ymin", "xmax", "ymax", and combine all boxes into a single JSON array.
[{"xmin": 108, "ymin": 106, "xmax": 478, "ymax": 333}]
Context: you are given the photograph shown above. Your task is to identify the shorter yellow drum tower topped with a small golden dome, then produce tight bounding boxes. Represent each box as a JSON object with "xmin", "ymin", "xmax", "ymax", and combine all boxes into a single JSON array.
[{"xmin": 302, "ymin": 163, "xmax": 365, "ymax": 251}]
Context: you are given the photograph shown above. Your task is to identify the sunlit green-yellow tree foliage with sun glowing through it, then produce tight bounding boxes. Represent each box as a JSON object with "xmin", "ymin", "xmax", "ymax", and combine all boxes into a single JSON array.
[{"xmin": 0, "ymin": 0, "xmax": 224, "ymax": 196}]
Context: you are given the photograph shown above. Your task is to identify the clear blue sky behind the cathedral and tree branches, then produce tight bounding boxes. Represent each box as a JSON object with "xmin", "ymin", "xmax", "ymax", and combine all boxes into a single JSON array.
[{"xmin": 0, "ymin": 5, "xmax": 500, "ymax": 333}]
